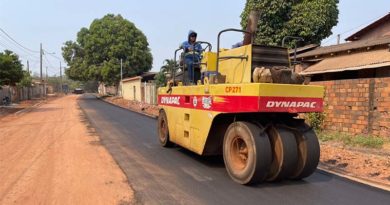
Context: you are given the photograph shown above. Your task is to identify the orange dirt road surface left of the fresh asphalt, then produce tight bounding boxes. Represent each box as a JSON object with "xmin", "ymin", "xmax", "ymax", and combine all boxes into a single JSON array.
[{"xmin": 0, "ymin": 95, "xmax": 133, "ymax": 204}]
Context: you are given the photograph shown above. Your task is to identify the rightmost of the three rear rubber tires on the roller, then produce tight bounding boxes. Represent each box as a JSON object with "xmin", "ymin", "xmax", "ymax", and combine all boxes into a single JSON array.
[{"xmin": 290, "ymin": 123, "xmax": 320, "ymax": 180}]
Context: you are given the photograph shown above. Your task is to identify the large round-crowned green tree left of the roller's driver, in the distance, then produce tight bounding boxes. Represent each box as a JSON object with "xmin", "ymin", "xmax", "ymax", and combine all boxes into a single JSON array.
[{"xmin": 62, "ymin": 14, "xmax": 153, "ymax": 85}]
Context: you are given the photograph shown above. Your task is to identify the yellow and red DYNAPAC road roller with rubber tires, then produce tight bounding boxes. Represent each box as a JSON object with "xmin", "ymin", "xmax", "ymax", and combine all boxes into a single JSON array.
[{"xmin": 157, "ymin": 14, "xmax": 324, "ymax": 184}]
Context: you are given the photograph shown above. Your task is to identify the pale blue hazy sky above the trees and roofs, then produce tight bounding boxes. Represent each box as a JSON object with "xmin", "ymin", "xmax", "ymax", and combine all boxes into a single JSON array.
[{"xmin": 0, "ymin": 0, "xmax": 390, "ymax": 76}]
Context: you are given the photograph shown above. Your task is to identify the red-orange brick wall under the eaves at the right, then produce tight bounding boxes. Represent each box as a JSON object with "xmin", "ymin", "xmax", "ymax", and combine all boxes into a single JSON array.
[{"xmin": 311, "ymin": 77, "xmax": 390, "ymax": 138}]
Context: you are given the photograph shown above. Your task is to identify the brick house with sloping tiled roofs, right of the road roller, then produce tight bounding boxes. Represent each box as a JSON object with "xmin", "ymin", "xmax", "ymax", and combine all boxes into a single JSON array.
[{"xmin": 297, "ymin": 13, "xmax": 390, "ymax": 137}]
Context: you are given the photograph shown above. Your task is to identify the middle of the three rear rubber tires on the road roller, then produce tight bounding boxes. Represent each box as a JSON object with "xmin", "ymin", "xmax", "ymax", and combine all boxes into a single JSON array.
[{"xmin": 267, "ymin": 126, "xmax": 298, "ymax": 181}]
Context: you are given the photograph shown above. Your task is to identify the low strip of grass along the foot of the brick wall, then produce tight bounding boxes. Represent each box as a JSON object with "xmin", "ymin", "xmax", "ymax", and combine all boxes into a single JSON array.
[{"xmin": 318, "ymin": 133, "xmax": 385, "ymax": 148}]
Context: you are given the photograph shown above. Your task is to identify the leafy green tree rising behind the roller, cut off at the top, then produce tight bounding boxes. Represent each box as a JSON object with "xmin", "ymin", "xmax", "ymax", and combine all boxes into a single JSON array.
[{"xmin": 241, "ymin": 0, "xmax": 339, "ymax": 46}]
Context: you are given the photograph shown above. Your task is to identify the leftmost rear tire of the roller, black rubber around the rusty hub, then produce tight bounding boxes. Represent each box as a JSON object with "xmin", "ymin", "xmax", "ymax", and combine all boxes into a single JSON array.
[{"xmin": 223, "ymin": 121, "xmax": 272, "ymax": 185}]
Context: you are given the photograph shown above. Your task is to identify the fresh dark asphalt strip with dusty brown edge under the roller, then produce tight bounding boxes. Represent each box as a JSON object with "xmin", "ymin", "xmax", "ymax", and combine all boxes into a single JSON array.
[{"xmin": 79, "ymin": 94, "xmax": 390, "ymax": 205}]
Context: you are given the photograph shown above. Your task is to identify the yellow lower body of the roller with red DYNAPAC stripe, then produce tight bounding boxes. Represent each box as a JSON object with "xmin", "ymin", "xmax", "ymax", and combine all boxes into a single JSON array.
[{"xmin": 158, "ymin": 81, "xmax": 324, "ymax": 155}]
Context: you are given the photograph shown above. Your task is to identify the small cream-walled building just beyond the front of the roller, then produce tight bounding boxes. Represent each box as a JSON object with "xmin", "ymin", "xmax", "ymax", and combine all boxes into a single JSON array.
[{"xmin": 122, "ymin": 72, "xmax": 157, "ymax": 104}]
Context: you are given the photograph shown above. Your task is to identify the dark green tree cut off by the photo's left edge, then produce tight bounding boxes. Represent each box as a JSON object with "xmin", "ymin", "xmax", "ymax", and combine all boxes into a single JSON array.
[{"xmin": 0, "ymin": 50, "xmax": 23, "ymax": 86}]
